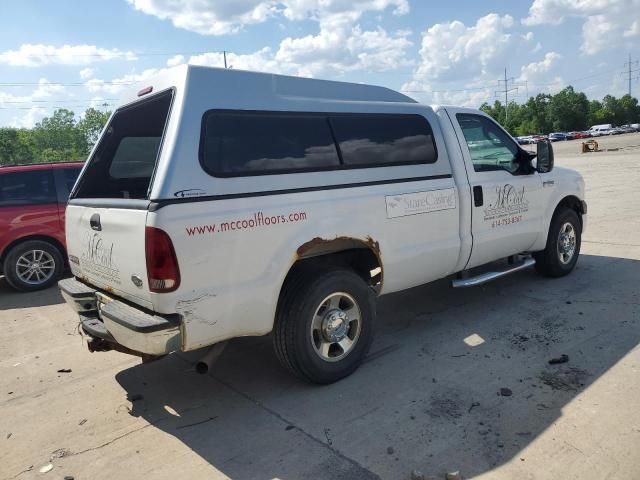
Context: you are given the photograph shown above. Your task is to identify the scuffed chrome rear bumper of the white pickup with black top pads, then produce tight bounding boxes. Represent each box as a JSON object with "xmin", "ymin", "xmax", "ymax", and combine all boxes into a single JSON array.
[{"xmin": 58, "ymin": 278, "xmax": 182, "ymax": 355}]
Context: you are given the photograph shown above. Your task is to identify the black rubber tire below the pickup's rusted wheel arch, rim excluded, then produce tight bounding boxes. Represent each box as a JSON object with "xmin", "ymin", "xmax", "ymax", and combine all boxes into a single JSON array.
[{"xmin": 273, "ymin": 267, "xmax": 376, "ymax": 384}]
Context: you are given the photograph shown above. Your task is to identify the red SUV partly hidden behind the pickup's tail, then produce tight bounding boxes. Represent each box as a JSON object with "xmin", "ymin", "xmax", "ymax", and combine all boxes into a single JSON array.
[{"xmin": 0, "ymin": 162, "xmax": 82, "ymax": 291}]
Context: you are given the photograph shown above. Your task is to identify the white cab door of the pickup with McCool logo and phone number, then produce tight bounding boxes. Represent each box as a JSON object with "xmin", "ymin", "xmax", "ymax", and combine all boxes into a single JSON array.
[{"xmin": 448, "ymin": 109, "xmax": 546, "ymax": 268}]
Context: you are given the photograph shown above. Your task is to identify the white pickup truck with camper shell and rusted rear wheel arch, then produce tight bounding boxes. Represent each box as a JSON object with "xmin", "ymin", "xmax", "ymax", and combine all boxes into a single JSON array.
[{"xmin": 60, "ymin": 66, "xmax": 587, "ymax": 383}]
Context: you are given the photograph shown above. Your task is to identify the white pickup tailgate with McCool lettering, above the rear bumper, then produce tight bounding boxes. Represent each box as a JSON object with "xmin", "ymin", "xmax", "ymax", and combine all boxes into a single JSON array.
[{"xmin": 66, "ymin": 205, "xmax": 152, "ymax": 308}]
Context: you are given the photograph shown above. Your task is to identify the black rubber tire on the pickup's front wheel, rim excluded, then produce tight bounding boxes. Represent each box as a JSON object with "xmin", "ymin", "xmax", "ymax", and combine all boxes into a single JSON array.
[{"xmin": 533, "ymin": 208, "xmax": 582, "ymax": 277}]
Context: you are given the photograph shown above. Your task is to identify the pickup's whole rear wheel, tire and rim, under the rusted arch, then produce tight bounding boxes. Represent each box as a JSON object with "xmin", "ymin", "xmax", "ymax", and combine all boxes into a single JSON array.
[{"xmin": 273, "ymin": 268, "xmax": 375, "ymax": 384}]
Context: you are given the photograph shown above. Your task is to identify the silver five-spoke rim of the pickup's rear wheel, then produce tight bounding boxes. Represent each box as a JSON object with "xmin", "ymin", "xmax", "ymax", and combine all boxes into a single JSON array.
[{"xmin": 310, "ymin": 292, "xmax": 362, "ymax": 362}]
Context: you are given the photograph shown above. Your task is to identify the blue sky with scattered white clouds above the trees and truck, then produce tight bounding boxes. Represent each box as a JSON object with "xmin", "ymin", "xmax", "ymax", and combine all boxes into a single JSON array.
[{"xmin": 0, "ymin": 0, "xmax": 640, "ymax": 128}]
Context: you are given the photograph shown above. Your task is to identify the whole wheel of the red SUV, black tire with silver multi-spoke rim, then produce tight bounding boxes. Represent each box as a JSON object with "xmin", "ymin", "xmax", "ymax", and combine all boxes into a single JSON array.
[{"xmin": 3, "ymin": 240, "xmax": 64, "ymax": 291}]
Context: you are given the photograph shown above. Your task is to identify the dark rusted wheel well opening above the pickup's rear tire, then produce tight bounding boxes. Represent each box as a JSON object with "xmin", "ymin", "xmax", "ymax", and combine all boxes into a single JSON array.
[{"xmin": 283, "ymin": 237, "xmax": 383, "ymax": 288}]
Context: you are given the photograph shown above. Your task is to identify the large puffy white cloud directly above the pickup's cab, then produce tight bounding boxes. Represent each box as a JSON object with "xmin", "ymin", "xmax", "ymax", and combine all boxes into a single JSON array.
[{"xmin": 401, "ymin": 13, "xmax": 563, "ymax": 107}]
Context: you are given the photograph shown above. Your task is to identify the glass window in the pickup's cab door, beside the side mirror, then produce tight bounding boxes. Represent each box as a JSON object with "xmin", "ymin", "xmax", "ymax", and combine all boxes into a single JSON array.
[{"xmin": 456, "ymin": 113, "xmax": 520, "ymax": 174}]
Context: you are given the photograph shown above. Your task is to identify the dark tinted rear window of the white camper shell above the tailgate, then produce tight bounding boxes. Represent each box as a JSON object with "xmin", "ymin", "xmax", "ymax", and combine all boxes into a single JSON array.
[{"xmin": 72, "ymin": 89, "xmax": 174, "ymax": 199}]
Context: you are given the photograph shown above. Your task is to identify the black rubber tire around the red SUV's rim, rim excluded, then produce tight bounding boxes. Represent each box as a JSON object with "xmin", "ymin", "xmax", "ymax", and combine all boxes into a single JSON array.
[{"xmin": 2, "ymin": 240, "xmax": 64, "ymax": 292}]
